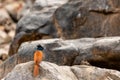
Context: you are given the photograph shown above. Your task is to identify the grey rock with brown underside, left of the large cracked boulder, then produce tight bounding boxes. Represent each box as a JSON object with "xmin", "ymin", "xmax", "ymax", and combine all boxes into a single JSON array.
[{"xmin": 9, "ymin": 0, "xmax": 68, "ymax": 55}]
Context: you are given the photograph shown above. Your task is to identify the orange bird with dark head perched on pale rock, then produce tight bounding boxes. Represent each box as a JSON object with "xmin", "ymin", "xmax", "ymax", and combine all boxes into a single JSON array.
[{"xmin": 33, "ymin": 45, "xmax": 44, "ymax": 77}]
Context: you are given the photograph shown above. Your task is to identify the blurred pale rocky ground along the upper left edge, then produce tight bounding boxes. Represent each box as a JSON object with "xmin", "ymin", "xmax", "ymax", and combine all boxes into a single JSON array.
[{"xmin": 0, "ymin": 0, "xmax": 33, "ymax": 63}]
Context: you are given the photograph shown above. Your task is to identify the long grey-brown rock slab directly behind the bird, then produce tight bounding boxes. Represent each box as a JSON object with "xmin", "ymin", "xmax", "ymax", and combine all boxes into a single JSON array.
[{"xmin": 0, "ymin": 37, "xmax": 120, "ymax": 77}]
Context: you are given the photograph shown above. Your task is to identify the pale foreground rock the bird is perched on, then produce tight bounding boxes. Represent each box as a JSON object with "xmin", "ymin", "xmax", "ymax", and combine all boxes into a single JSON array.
[{"xmin": 4, "ymin": 62, "xmax": 120, "ymax": 80}]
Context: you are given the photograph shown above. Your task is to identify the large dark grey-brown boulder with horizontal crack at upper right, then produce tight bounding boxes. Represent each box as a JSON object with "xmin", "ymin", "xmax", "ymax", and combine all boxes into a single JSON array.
[{"xmin": 54, "ymin": 0, "xmax": 120, "ymax": 39}]
